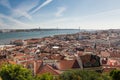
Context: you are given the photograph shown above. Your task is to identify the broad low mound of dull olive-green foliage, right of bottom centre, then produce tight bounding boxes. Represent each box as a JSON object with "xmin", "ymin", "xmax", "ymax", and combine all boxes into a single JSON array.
[{"xmin": 60, "ymin": 70, "xmax": 110, "ymax": 80}]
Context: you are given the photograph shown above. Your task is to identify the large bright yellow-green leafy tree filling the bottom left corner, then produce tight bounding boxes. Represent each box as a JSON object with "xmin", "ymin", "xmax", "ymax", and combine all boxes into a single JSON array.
[{"xmin": 0, "ymin": 64, "xmax": 33, "ymax": 80}]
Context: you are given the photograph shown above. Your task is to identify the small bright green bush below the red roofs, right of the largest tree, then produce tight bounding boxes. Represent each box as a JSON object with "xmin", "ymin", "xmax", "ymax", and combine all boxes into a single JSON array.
[{"xmin": 35, "ymin": 73, "xmax": 54, "ymax": 80}]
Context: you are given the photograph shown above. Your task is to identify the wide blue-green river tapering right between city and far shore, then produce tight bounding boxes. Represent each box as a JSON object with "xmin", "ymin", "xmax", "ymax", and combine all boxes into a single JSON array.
[{"xmin": 0, "ymin": 29, "xmax": 79, "ymax": 45}]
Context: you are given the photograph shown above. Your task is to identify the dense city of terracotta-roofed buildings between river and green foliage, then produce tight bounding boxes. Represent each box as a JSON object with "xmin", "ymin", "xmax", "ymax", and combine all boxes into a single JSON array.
[{"xmin": 0, "ymin": 30, "xmax": 120, "ymax": 75}]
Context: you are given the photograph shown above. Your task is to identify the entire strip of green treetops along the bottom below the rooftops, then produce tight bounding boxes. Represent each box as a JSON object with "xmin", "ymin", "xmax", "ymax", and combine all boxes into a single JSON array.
[{"xmin": 0, "ymin": 64, "xmax": 120, "ymax": 80}]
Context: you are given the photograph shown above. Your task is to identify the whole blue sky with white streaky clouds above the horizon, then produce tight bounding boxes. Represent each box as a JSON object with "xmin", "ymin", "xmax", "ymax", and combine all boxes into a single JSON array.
[{"xmin": 0, "ymin": 0, "xmax": 120, "ymax": 29}]
